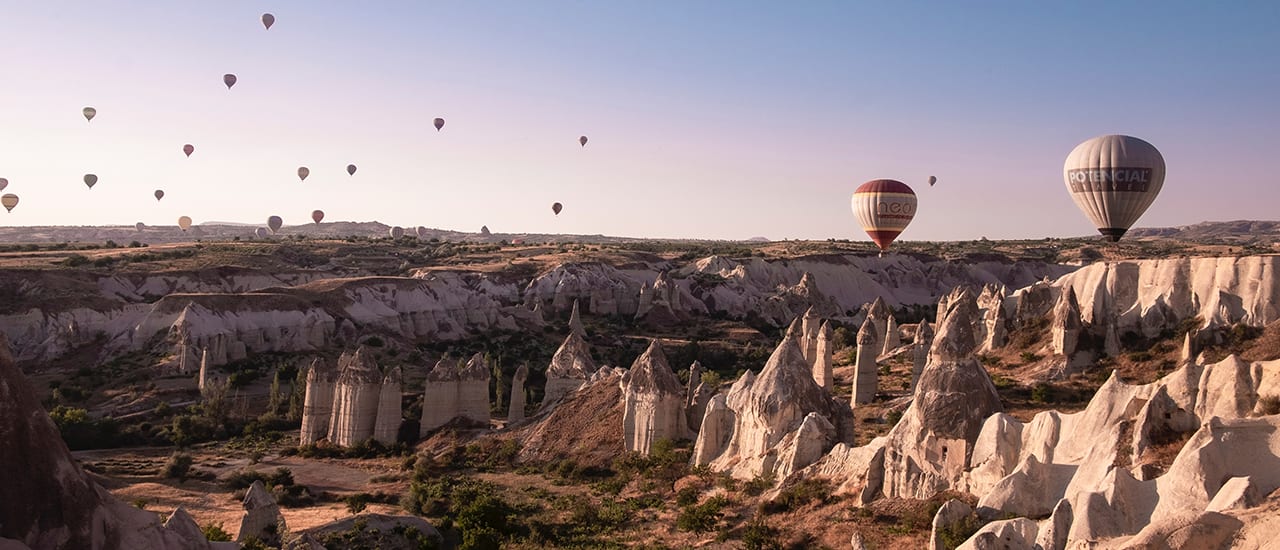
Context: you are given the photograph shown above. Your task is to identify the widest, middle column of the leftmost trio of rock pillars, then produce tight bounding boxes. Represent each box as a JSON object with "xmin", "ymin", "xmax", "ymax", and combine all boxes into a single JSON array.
[{"xmin": 329, "ymin": 348, "xmax": 383, "ymax": 446}]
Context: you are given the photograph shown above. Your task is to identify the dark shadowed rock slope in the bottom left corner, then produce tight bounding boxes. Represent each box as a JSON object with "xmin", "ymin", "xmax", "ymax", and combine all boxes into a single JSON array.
[{"xmin": 0, "ymin": 334, "xmax": 197, "ymax": 550}]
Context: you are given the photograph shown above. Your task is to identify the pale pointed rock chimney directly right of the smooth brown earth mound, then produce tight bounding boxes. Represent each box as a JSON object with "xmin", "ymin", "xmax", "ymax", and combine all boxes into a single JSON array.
[{"xmin": 620, "ymin": 340, "xmax": 690, "ymax": 454}]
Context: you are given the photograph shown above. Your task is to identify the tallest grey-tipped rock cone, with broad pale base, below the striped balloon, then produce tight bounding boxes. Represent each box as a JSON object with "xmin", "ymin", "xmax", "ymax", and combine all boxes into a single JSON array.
[{"xmin": 883, "ymin": 294, "xmax": 1001, "ymax": 499}]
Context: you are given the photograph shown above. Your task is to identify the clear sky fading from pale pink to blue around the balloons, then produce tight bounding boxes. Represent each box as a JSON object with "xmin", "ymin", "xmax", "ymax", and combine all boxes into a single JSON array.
[{"xmin": 0, "ymin": 0, "xmax": 1280, "ymax": 240}]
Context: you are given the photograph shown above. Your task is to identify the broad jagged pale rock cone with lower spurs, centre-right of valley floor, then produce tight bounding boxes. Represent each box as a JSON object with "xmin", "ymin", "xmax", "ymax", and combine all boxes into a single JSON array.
[{"xmin": 694, "ymin": 334, "xmax": 852, "ymax": 481}]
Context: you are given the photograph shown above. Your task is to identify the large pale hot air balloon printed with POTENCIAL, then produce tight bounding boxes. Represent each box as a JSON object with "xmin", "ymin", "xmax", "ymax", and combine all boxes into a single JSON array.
[{"xmin": 1062, "ymin": 136, "xmax": 1165, "ymax": 242}]
